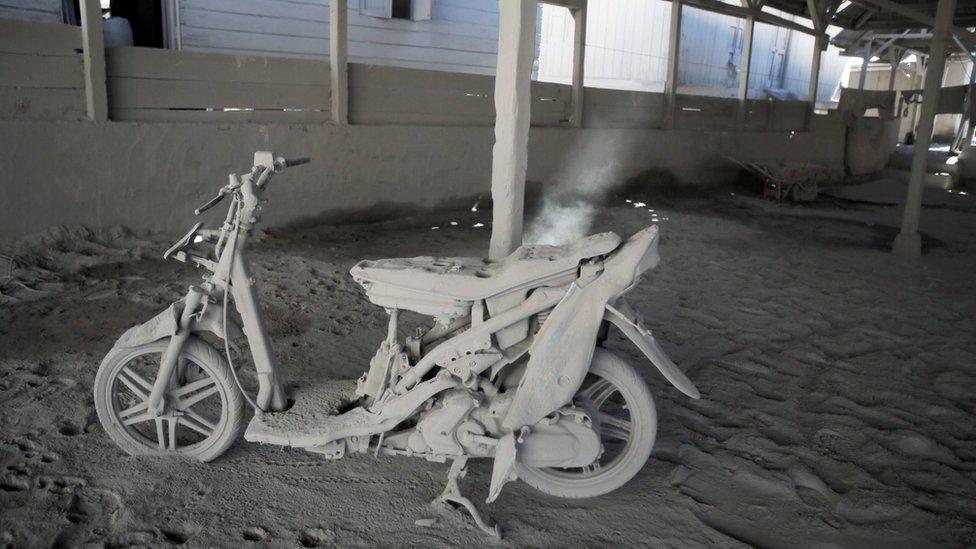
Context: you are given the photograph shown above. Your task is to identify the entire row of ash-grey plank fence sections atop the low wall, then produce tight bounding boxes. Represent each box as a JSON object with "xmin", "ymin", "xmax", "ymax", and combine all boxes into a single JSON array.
[{"xmin": 0, "ymin": 19, "xmax": 807, "ymax": 131}]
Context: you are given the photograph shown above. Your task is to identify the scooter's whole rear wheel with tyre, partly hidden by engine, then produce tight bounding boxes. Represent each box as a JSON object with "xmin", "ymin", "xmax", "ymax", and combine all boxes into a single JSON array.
[{"xmin": 516, "ymin": 349, "xmax": 657, "ymax": 499}]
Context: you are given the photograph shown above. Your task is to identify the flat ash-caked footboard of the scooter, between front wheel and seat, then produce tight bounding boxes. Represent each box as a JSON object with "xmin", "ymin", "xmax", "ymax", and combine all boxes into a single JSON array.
[{"xmin": 244, "ymin": 379, "xmax": 366, "ymax": 448}]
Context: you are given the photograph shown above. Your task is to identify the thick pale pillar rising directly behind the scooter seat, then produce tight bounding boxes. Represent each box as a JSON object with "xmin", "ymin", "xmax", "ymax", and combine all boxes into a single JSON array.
[{"xmin": 488, "ymin": 0, "xmax": 536, "ymax": 259}]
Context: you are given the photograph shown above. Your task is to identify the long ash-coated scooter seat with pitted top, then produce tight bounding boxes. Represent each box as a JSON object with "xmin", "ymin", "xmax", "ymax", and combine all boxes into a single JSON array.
[{"xmin": 350, "ymin": 232, "xmax": 620, "ymax": 308}]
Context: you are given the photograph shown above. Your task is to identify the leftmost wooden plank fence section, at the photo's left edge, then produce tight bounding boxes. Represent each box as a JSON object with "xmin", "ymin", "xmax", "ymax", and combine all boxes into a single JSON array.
[{"xmin": 0, "ymin": 19, "xmax": 85, "ymax": 120}]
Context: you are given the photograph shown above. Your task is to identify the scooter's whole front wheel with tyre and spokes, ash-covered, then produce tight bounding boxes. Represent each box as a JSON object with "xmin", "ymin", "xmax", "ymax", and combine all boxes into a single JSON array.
[{"xmin": 95, "ymin": 337, "xmax": 244, "ymax": 461}]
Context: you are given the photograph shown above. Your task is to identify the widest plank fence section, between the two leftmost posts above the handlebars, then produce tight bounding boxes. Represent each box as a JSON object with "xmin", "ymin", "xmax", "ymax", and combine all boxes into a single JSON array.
[{"xmin": 106, "ymin": 47, "xmax": 329, "ymax": 122}]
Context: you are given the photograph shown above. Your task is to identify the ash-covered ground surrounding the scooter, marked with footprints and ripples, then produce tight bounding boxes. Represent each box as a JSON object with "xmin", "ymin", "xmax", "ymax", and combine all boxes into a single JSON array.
[{"xmin": 0, "ymin": 183, "xmax": 976, "ymax": 547}]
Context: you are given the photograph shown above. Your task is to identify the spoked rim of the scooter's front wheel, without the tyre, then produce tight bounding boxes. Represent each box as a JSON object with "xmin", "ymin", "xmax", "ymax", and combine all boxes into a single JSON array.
[{"xmin": 106, "ymin": 349, "xmax": 228, "ymax": 453}]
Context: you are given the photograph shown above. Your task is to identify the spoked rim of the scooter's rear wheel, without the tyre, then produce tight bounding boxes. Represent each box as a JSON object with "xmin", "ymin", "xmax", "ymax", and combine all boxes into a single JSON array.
[{"xmin": 536, "ymin": 372, "xmax": 640, "ymax": 482}]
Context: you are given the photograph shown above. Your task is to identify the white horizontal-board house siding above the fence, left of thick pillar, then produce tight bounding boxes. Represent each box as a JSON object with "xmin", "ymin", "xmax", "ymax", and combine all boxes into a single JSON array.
[{"xmin": 179, "ymin": 0, "xmax": 508, "ymax": 74}]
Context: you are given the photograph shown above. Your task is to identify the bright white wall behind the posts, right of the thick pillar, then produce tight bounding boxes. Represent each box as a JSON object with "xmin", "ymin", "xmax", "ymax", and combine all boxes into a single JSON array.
[{"xmin": 539, "ymin": 0, "xmax": 847, "ymax": 102}]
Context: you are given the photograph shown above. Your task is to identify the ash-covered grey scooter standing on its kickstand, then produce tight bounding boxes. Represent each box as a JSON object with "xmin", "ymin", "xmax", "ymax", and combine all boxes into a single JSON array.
[{"xmin": 95, "ymin": 152, "xmax": 699, "ymax": 535}]
